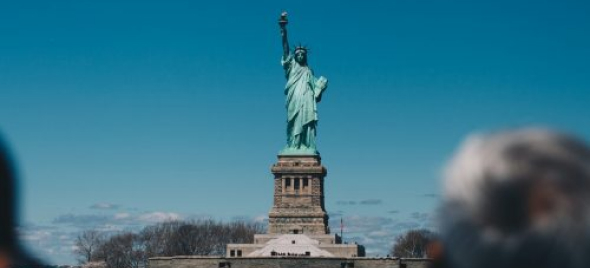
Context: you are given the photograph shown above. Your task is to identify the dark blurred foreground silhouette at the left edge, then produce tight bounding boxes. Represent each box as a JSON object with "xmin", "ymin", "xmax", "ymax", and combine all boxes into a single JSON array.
[{"xmin": 0, "ymin": 138, "xmax": 40, "ymax": 268}]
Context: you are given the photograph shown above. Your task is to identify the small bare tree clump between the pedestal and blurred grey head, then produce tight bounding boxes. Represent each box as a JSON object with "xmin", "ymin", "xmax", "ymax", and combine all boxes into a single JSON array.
[{"xmin": 391, "ymin": 229, "xmax": 435, "ymax": 258}]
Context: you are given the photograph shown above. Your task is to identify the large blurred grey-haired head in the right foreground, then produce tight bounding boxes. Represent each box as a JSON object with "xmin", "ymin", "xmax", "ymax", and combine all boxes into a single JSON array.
[{"xmin": 435, "ymin": 129, "xmax": 590, "ymax": 268}]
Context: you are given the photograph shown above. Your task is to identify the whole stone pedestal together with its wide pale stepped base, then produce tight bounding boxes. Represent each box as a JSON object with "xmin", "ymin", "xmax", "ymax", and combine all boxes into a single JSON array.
[{"xmin": 227, "ymin": 154, "xmax": 364, "ymax": 260}]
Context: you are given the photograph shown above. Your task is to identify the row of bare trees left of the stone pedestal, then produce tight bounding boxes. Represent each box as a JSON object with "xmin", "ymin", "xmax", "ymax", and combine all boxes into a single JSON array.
[{"xmin": 74, "ymin": 220, "xmax": 264, "ymax": 268}]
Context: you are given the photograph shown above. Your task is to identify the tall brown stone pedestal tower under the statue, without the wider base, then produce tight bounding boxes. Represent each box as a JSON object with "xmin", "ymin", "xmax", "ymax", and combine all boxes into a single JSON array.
[{"xmin": 268, "ymin": 155, "xmax": 329, "ymax": 235}]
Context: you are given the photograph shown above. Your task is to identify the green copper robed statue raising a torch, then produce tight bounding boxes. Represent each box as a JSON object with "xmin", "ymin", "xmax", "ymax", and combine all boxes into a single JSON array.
[{"xmin": 279, "ymin": 12, "xmax": 328, "ymax": 155}]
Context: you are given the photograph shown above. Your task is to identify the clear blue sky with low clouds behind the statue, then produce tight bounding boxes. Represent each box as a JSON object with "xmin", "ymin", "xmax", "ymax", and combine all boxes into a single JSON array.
[{"xmin": 0, "ymin": 0, "xmax": 590, "ymax": 263}]
